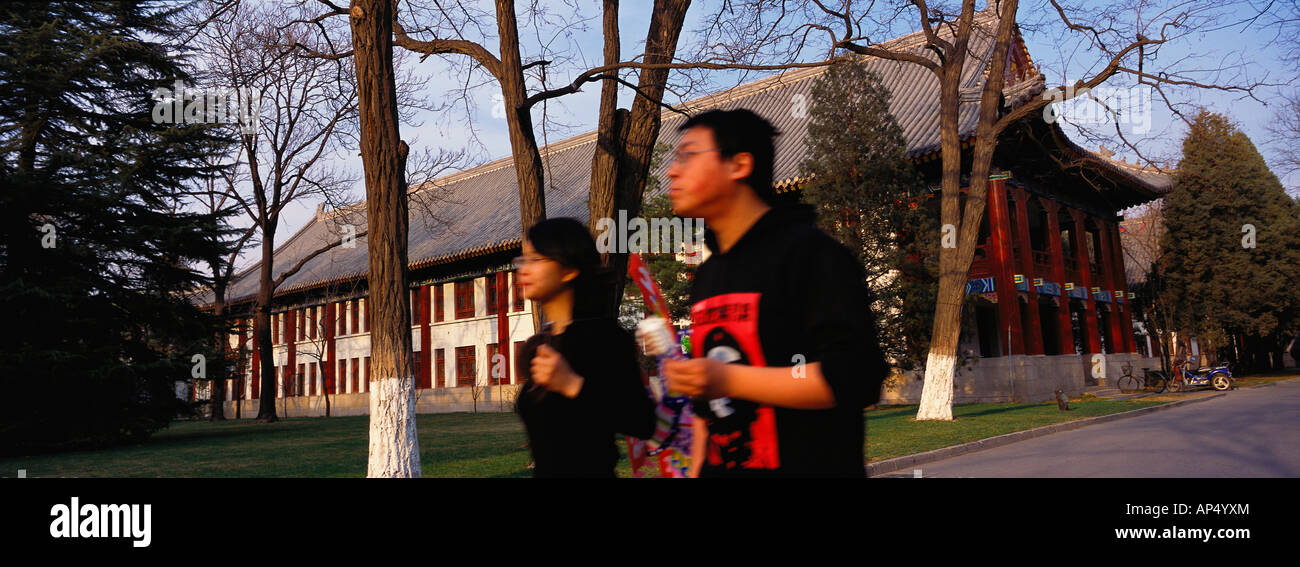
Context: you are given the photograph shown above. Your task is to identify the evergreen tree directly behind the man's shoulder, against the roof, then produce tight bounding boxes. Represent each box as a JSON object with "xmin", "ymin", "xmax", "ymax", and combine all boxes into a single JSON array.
[{"xmin": 801, "ymin": 57, "xmax": 939, "ymax": 368}]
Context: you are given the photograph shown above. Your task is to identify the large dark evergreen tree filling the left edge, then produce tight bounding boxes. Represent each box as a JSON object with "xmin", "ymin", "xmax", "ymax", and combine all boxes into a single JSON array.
[{"xmin": 0, "ymin": 1, "xmax": 229, "ymax": 453}]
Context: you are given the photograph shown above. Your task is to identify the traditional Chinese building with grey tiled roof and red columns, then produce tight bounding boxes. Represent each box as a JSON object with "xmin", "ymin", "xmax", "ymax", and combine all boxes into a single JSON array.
[{"xmin": 205, "ymin": 5, "xmax": 1170, "ymax": 416}]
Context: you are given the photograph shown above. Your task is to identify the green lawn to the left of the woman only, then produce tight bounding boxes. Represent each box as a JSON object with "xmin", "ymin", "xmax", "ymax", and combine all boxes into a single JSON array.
[{"xmin": 0, "ymin": 414, "xmax": 530, "ymax": 477}]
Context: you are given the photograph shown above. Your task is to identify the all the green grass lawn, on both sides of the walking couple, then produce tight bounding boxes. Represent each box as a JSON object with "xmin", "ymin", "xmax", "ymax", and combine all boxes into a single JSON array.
[{"xmin": 0, "ymin": 399, "xmax": 1180, "ymax": 477}]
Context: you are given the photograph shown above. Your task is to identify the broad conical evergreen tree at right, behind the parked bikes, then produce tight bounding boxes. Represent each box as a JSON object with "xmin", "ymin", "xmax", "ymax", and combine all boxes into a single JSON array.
[{"xmin": 1160, "ymin": 111, "xmax": 1300, "ymax": 369}]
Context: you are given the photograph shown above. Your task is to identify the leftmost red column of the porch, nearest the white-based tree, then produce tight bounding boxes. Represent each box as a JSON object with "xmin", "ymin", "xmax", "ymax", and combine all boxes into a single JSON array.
[{"xmin": 988, "ymin": 179, "xmax": 1024, "ymax": 356}]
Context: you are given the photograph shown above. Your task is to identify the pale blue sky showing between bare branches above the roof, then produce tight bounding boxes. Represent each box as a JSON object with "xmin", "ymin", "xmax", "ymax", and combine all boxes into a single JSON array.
[{"xmin": 238, "ymin": 0, "xmax": 1300, "ymax": 274}]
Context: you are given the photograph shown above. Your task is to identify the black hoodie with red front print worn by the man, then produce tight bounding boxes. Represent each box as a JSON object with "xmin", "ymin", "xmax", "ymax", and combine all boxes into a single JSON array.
[{"xmin": 690, "ymin": 205, "xmax": 888, "ymax": 477}]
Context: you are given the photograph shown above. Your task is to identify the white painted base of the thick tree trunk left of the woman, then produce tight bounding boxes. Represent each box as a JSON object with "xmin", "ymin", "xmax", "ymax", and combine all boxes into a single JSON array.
[{"xmin": 365, "ymin": 376, "xmax": 420, "ymax": 479}]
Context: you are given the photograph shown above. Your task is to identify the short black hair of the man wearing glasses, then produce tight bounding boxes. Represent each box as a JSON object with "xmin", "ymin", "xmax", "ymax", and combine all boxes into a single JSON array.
[{"xmin": 677, "ymin": 108, "xmax": 781, "ymax": 204}]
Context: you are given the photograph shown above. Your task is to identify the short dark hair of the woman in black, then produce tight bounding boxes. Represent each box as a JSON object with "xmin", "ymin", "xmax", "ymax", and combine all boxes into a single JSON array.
[{"xmin": 528, "ymin": 217, "xmax": 615, "ymax": 319}]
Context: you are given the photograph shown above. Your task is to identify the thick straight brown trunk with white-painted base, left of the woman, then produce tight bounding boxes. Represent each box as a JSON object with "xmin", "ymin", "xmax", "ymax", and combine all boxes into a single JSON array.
[{"xmin": 351, "ymin": 0, "xmax": 421, "ymax": 477}]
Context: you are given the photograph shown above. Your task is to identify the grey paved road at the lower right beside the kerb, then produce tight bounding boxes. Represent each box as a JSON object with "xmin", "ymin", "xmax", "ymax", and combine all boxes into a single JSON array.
[{"xmin": 888, "ymin": 380, "xmax": 1300, "ymax": 477}]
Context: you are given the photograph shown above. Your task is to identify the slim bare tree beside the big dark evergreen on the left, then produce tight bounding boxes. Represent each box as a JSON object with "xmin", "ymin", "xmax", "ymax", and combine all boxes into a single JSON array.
[{"xmin": 185, "ymin": 4, "xmax": 364, "ymax": 421}]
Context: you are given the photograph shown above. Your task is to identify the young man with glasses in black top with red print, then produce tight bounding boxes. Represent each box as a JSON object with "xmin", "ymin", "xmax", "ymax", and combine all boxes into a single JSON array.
[{"xmin": 664, "ymin": 109, "xmax": 888, "ymax": 477}]
